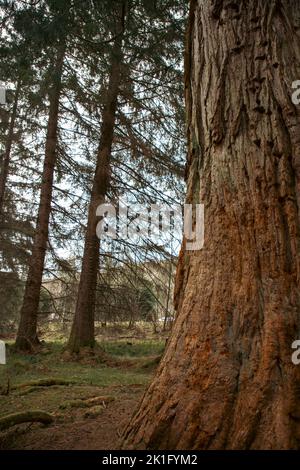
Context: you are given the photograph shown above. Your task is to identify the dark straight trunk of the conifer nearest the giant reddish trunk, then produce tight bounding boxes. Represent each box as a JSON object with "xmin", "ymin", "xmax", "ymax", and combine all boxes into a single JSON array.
[{"xmin": 68, "ymin": 2, "xmax": 126, "ymax": 352}]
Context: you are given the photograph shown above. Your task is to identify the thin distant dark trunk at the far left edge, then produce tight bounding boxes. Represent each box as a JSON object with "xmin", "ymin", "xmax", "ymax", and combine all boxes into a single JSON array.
[{"xmin": 0, "ymin": 80, "xmax": 21, "ymax": 217}]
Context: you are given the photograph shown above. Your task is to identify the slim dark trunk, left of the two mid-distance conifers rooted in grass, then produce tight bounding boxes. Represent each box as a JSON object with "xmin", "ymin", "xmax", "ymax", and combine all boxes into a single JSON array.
[{"xmin": 16, "ymin": 45, "xmax": 65, "ymax": 350}]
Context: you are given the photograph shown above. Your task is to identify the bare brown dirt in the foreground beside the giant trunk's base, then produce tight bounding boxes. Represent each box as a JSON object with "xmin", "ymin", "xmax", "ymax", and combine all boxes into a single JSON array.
[{"xmin": 0, "ymin": 385, "xmax": 144, "ymax": 450}]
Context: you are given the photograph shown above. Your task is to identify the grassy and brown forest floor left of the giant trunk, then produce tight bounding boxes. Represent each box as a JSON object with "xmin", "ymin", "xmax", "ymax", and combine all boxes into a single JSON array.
[{"xmin": 0, "ymin": 328, "xmax": 165, "ymax": 450}]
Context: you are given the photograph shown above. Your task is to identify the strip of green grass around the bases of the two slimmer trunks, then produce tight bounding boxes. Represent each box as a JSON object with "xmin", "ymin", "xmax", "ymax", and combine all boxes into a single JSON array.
[{"xmin": 0, "ymin": 340, "xmax": 164, "ymax": 387}]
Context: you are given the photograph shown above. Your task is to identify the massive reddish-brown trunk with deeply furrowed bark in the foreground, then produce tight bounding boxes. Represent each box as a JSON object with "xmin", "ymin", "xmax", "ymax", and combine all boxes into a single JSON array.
[{"xmin": 124, "ymin": 0, "xmax": 300, "ymax": 449}]
